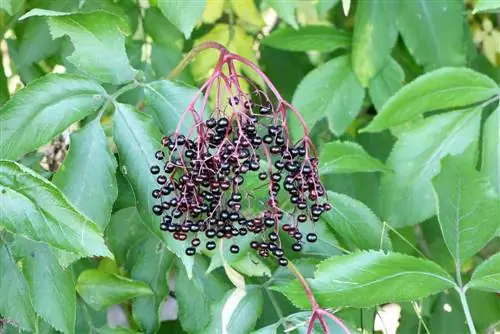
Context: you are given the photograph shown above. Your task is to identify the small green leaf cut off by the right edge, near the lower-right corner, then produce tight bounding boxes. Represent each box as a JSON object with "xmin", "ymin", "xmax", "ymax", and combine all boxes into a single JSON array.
[{"xmin": 467, "ymin": 253, "xmax": 500, "ymax": 293}]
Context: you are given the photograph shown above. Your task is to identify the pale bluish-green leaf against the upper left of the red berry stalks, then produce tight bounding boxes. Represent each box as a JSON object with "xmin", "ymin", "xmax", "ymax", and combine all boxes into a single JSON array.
[{"xmin": 144, "ymin": 80, "xmax": 198, "ymax": 135}]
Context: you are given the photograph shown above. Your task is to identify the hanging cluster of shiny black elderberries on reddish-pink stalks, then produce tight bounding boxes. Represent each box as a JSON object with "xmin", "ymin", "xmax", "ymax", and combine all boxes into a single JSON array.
[{"xmin": 151, "ymin": 45, "xmax": 331, "ymax": 266}]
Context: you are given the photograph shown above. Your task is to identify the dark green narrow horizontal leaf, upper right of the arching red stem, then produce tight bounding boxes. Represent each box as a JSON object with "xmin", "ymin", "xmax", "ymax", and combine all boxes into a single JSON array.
[{"xmin": 261, "ymin": 25, "xmax": 351, "ymax": 52}]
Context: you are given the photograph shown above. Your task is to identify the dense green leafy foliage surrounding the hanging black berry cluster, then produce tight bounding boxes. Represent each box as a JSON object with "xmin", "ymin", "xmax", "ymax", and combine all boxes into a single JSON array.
[{"xmin": 0, "ymin": 0, "xmax": 500, "ymax": 334}]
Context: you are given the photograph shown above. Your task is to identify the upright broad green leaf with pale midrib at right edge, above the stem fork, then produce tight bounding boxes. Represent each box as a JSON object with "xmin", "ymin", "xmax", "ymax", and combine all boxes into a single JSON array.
[{"xmin": 432, "ymin": 156, "xmax": 500, "ymax": 263}]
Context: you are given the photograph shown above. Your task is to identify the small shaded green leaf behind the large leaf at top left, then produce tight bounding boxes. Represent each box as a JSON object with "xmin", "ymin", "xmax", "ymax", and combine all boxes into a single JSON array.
[{"xmin": 17, "ymin": 17, "xmax": 60, "ymax": 66}]
